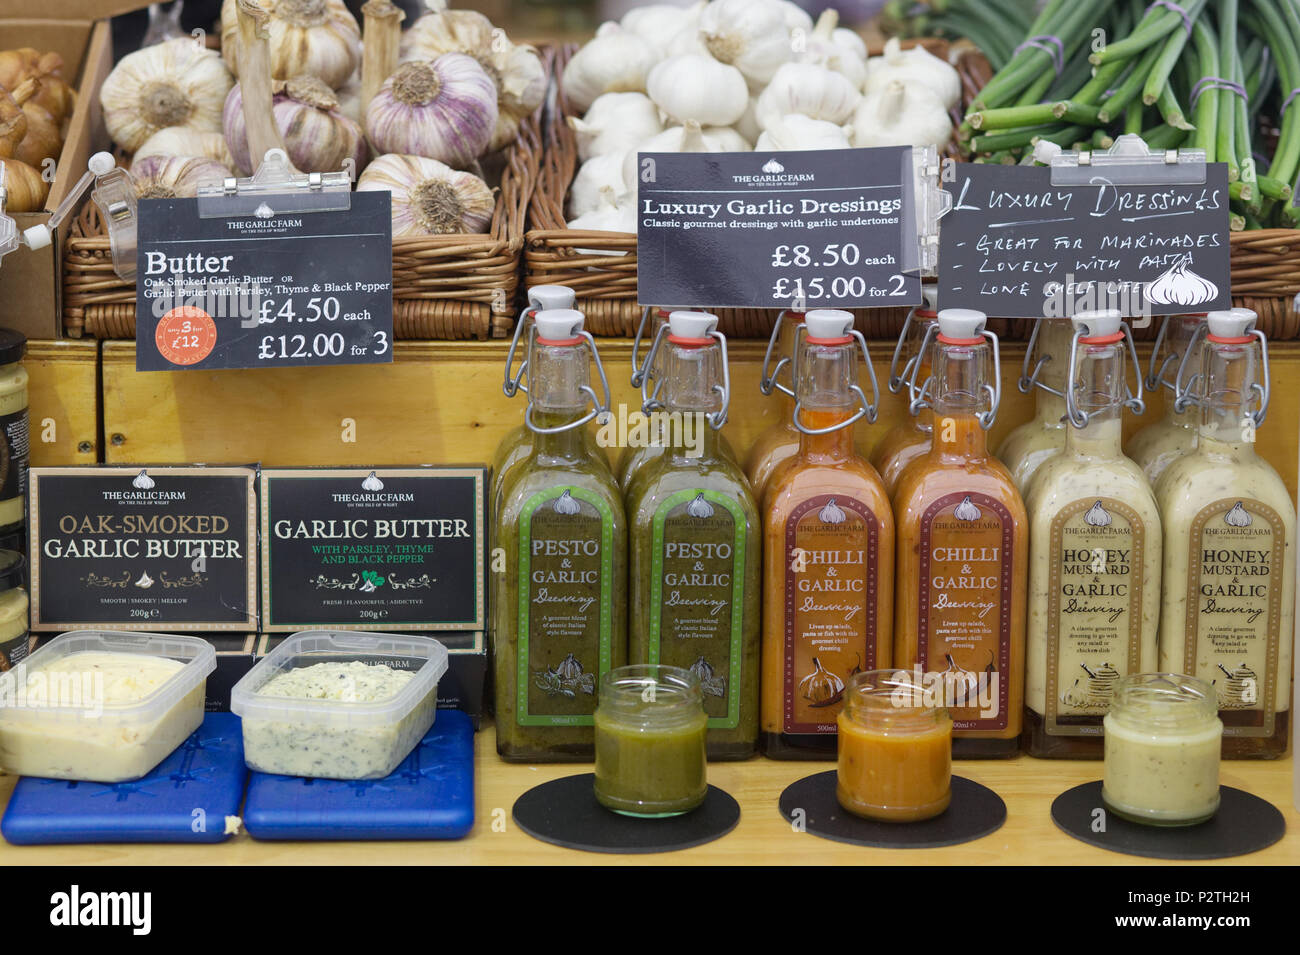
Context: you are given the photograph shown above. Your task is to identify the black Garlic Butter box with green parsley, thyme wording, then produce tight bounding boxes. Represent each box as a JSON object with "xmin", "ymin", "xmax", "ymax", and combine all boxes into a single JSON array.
[{"xmin": 260, "ymin": 468, "xmax": 488, "ymax": 633}]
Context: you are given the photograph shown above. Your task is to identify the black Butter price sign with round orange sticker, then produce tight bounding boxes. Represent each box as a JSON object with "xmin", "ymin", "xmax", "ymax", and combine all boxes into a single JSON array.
[{"xmin": 135, "ymin": 192, "xmax": 393, "ymax": 372}]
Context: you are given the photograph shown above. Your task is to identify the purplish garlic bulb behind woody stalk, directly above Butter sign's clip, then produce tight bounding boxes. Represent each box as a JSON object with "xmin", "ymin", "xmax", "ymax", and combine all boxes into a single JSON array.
[{"xmin": 222, "ymin": 77, "xmax": 367, "ymax": 173}]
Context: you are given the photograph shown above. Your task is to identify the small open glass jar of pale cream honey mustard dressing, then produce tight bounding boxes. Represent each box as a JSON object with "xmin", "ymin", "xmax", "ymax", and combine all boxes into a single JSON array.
[{"xmin": 1101, "ymin": 673, "xmax": 1223, "ymax": 825}]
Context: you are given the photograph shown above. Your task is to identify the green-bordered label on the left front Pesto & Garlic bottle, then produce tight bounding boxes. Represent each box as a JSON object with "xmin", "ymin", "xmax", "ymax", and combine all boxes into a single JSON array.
[{"xmin": 516, "ymin": 487, "xmax": 614, "ymax": 726}]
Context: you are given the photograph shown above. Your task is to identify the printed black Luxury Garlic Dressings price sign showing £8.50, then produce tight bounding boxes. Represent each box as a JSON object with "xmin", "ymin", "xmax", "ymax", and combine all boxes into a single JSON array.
[{"xmin": 637, "ymin": 147, "xmax": 920, "ymax": 308}]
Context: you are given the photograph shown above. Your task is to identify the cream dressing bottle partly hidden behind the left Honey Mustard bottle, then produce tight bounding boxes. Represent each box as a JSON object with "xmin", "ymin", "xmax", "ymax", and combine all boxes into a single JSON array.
[{"xmin": 997, "ymin": 318, "xmax": 1074, "ymax": 494}]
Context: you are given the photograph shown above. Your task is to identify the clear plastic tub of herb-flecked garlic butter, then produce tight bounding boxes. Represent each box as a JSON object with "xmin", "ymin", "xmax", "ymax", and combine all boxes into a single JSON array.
[{"xmin": 230, "ymin": 630, "xmax": 447, "ymax": 780}]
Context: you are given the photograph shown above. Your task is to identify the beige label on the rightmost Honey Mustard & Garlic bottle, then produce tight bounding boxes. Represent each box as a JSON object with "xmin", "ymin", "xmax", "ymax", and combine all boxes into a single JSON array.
[{"xmin": 1183, "ymin": 498, "xmax": 1291, "ymax": 737}]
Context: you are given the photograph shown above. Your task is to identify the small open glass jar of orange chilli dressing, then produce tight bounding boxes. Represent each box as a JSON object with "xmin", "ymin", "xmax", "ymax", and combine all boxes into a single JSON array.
[{"xmin": 836, "ymin": 670, "xmax": 953, "ymax": 822}]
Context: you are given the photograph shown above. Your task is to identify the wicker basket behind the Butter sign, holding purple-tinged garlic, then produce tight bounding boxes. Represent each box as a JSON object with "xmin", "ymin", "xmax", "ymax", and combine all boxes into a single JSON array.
[{"xmin": 64, "ymin": 49, "xmax": 555, "ymax": 340}]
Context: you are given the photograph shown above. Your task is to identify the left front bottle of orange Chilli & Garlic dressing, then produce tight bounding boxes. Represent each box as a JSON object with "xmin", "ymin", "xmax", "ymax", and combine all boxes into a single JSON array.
[{"xmin": 759, "ymin": 309, "xmax": 894, "ymax": 759}]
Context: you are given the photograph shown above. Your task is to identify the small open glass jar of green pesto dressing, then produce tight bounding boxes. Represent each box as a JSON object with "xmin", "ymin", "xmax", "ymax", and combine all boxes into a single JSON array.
[{"xmin": 595, "ymin": 664, "xmax": 709, "ymax": 817}]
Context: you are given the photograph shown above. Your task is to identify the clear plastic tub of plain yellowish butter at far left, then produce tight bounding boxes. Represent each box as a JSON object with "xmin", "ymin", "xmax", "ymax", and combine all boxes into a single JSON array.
[{"xmin": 0, "ymin": 630, "xmax": 217, "ymax": 782}]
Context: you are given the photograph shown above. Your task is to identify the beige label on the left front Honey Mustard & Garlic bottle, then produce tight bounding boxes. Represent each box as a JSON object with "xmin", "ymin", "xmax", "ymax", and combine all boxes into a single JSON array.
[{"xmin": 1044, "ymin": 498, "xmax": 1147, "ymax": 737}]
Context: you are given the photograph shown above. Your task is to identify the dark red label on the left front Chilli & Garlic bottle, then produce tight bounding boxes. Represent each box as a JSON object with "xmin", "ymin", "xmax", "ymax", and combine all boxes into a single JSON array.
[{"xmin": 783, "ymin": 495, "xmax": 880, "ymax": 733}]
